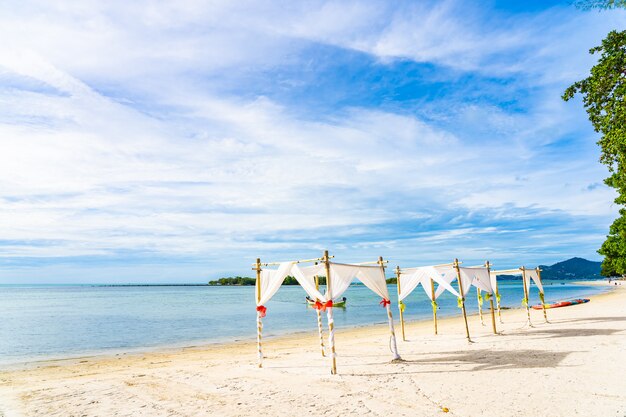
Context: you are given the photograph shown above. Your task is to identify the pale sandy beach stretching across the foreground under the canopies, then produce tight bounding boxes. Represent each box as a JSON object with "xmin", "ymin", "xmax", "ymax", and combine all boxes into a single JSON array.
[{"xmin": 0, "ymin": 285, "xmax": 626, "ymax": 417}]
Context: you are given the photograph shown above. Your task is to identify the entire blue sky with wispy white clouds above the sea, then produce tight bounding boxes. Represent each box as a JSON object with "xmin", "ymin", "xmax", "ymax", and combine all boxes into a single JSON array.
[{"xmin": 0, "ymin": 0, "xmax": 626, "ymax": 283}]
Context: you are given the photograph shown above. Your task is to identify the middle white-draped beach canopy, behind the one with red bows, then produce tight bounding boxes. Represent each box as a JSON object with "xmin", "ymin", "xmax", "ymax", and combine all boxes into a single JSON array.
[{"xmin": 396, "ymin": 259, "xmax": 471, "ymax": 342}]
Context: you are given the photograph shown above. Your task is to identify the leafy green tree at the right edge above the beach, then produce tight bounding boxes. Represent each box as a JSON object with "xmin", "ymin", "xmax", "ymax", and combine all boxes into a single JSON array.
[{"xmin": 563, "ymin": 30, "xmax": 626, "ymax": 275}]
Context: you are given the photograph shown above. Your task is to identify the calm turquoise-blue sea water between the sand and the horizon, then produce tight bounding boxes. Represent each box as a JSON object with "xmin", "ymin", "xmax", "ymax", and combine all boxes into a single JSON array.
[{"xmin": 0, "ymin": 282, "xmax": 608, "ymax": 365}]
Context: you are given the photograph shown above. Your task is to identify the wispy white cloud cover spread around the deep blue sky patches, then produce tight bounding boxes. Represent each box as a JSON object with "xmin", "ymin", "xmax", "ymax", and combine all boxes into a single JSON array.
[{"xmin": 0, "ymin": 2, "xmax": 623, "ymax": 280}]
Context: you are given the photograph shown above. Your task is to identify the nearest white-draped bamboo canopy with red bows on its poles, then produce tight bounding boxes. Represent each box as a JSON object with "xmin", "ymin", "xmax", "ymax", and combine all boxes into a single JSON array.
[{"xmin": 255, "ymin": 251, "xmax": 401, "ymax": 374}]
